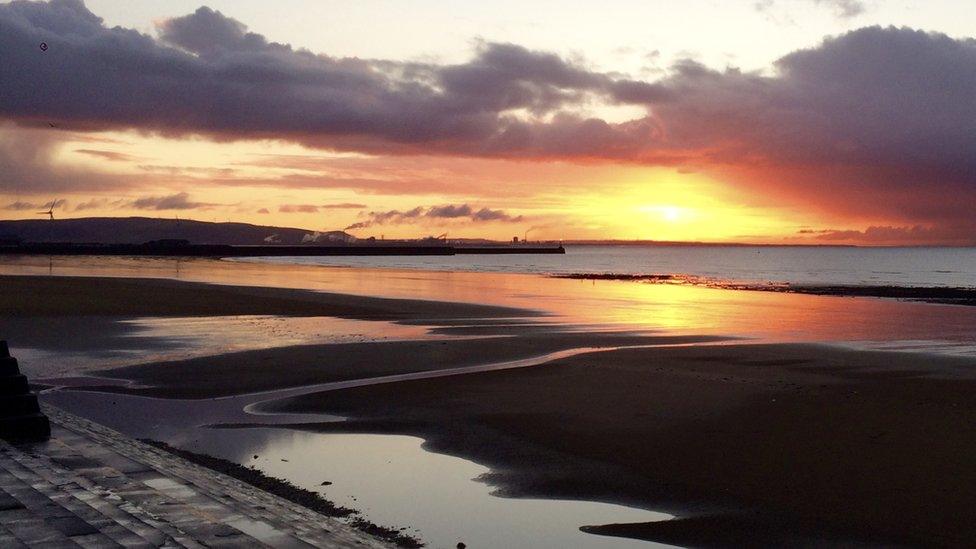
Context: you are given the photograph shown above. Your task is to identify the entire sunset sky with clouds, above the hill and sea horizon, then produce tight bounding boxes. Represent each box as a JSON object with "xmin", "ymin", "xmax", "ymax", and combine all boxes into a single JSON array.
[{"xmin": 0, "ymin": 0, "xmax": 976, "ymax": 245}]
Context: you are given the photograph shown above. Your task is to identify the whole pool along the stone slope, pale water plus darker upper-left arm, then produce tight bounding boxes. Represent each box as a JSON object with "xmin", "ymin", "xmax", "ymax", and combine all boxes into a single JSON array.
[{"xmin": 42, "ymin": 391, "xmax": 671, "ymax": 548}]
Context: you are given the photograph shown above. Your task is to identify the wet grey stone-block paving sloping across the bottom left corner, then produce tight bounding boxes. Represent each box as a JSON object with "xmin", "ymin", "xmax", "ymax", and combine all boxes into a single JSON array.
[{"xmin": 0, "ymin": 406, "xmax": 389, "ymax": 548}]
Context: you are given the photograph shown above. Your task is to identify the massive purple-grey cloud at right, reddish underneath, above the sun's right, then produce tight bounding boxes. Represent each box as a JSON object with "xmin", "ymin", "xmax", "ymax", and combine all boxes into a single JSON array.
[{"xmin": 654, "ymin": 27, "xmax": 976, "ymax": 221}]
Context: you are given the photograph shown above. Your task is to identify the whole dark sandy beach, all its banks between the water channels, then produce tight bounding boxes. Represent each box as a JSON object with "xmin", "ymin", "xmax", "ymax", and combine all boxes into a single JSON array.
[{"xmin": 0, "ymin": 277, "xmax": 976, "ymax": 546}]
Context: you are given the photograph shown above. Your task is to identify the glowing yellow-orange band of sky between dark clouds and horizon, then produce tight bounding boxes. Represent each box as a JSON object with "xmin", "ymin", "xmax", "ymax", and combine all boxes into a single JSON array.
[{"xmin": 0, "ymin": 128, "xmax": 936, "ymax": 244}]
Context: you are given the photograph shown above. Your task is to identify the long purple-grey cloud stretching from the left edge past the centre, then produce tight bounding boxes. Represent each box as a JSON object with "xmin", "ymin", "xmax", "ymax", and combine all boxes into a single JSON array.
[{"xmin": 0, "ymin": 0, "xmax": 666, "ymax": 155}]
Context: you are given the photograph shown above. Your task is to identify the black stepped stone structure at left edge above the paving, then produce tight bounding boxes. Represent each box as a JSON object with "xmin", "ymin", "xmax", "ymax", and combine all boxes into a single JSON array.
[{"xmin": 0, "ymin": 341, "xmax": 51, "ymax": 441}]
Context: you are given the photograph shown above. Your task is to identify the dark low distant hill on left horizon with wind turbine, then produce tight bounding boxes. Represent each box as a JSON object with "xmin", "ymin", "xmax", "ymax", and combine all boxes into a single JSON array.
[{"xmin": 0, "ymin": 217, "xmax": 356, "ymax": 245}]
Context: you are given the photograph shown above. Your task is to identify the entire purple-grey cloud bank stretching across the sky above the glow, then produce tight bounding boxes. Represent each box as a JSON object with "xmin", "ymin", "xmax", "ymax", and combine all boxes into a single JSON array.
[{"xmin": 0, "ymin": 0, "xmax": 976, "ymax": 240}]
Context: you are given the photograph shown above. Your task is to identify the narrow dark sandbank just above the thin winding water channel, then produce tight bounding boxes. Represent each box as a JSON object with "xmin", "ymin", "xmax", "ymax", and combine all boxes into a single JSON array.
[{"xmin": 98, "ymin": 333, "xmax": 718, "ymax": 398}]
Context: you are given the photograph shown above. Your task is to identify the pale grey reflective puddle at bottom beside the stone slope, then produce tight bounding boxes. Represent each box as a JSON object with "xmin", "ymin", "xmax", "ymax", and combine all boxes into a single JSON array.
[{"xmin": 184, "ymin": 428, "xmax": 671, "ymax": 549}]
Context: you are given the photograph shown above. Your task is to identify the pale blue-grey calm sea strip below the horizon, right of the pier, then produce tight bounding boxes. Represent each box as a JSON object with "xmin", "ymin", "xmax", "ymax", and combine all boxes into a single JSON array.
[{"xmin": 240, "ymin": 245, "xmax": 976, "ymax": 288}]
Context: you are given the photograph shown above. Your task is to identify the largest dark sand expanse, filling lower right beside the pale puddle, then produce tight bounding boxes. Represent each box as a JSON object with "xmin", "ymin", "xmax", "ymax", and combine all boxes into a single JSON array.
[{"xmin": 258, "ymin": 345, "xmax": 976, "ymax": 546}]
